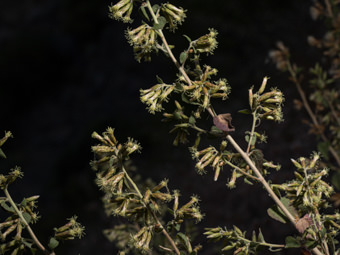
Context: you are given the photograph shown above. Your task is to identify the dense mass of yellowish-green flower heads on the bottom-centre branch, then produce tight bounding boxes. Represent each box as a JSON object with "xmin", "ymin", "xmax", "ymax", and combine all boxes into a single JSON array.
[{"xmin": 91, "ymin": 128, "xmax": 203, "ymax": 252}]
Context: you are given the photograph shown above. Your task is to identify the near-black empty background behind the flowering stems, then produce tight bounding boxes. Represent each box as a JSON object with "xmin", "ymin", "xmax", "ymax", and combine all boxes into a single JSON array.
[{"xmin": 0, "ymin": 0, "xmax": 320, "ymax": 255}]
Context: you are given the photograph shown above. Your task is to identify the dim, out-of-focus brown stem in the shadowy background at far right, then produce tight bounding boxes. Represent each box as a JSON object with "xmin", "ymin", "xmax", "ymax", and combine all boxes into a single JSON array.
[{"xmin": 287, "ymin": 61, "xmax": 340, "ymax": 167}]
